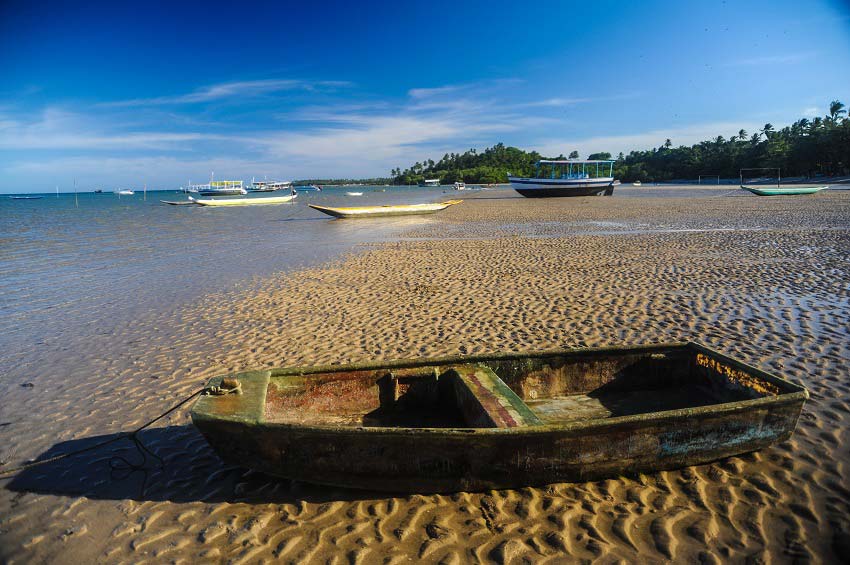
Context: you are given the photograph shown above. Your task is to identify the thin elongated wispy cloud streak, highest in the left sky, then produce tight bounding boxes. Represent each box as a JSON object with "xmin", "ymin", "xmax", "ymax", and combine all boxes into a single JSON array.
[{"xmin": 100, "ymin": 79, "xmax": 351, "ymax": 108}]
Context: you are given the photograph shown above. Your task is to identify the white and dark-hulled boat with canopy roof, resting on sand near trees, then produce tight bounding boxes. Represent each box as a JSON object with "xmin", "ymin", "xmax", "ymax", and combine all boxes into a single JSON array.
[{"xmin": 508, "ymin": 159, "xmax": 620, "ymax": 198}]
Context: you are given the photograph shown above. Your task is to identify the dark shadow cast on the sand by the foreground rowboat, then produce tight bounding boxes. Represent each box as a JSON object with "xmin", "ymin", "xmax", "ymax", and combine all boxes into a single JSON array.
[{"xmin": 4, "ymin": 426, "xmax": 374, "ymax": 504}]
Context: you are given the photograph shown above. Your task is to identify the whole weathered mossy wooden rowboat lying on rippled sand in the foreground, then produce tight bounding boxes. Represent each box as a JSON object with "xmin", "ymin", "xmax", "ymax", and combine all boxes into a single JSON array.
[{"xmin": 192, "ymin": 343, "xmax": 808, "ymax": 493}]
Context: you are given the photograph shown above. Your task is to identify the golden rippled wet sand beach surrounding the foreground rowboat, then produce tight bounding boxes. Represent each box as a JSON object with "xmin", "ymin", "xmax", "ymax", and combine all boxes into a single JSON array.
[{"xmin": 0, "ymin": 187, "xmax": 850, "ymax": 563}]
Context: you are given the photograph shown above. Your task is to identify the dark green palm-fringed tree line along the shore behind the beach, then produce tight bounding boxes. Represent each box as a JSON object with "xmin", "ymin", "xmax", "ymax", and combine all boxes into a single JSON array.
[{"xmin": 392, "ymin": 100, "xmax": 850, "ymax": 184}]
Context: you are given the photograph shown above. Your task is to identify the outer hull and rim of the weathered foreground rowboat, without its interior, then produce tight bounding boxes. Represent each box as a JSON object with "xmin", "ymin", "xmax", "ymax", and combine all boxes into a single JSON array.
[{"xmin": 192, "ymin": 344, "xmax": 807, "ymax": 493}]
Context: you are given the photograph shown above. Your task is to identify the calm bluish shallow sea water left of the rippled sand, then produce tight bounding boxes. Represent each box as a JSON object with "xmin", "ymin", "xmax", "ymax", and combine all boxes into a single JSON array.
[{"xmin": 0, "ymin": 183, "xmax": 446, "ymax": 372}]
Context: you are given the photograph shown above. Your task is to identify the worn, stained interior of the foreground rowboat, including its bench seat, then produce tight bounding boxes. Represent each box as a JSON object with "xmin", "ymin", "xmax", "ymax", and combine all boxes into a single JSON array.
[{"xmin": 264, "ymin": 347, "xmax": 790, "ymax": 428}]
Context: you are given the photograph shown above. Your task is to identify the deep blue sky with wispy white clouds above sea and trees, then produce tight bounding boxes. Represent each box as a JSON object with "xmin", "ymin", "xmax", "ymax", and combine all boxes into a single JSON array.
[{"xmin": 0, "ymin": 0, "xmax": 850, "ymax": 192}]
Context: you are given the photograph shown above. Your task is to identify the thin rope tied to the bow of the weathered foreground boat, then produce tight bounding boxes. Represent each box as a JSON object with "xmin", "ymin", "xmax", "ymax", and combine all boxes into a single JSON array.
[{"xmin": 0, "ymin": 378, "xmax": 222, "ymax": 479}]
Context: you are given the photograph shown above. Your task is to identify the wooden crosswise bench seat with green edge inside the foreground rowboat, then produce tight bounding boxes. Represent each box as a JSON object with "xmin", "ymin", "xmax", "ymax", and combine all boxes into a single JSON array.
[{"xmin": 440, "ymin": 365, "xmax": 543, "ymax": 428}]
